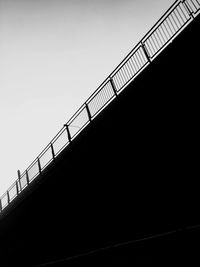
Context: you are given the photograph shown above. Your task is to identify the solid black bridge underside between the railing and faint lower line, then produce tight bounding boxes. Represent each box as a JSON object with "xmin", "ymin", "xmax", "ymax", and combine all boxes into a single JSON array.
[{"xmin": 0, "ymin": 12, "xmax": 200, "ymax": 266}]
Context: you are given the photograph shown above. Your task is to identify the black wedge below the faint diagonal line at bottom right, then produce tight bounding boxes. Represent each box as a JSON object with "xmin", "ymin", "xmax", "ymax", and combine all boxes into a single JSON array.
[{"xmin": 38, "ymin": 226, "xmax": 200, "ymax": 267}]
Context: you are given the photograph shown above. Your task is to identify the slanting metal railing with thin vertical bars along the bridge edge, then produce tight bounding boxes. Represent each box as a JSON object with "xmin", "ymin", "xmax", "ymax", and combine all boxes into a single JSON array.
[{"xmin": 0, "ymin": 0, "xmax": 200, "ymax": 212}]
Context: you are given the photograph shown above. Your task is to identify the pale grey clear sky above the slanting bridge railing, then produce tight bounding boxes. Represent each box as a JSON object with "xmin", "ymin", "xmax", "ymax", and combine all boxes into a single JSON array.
[{"xmin": 0, "ymin": 0, "xmax": 174, "ymax": 195}]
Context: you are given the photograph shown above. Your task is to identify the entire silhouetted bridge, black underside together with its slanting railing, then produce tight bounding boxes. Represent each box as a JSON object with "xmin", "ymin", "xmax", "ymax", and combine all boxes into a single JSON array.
[{"xmin": 0, "ymin": 0, "xmax": 200, "ymax": 266}]
